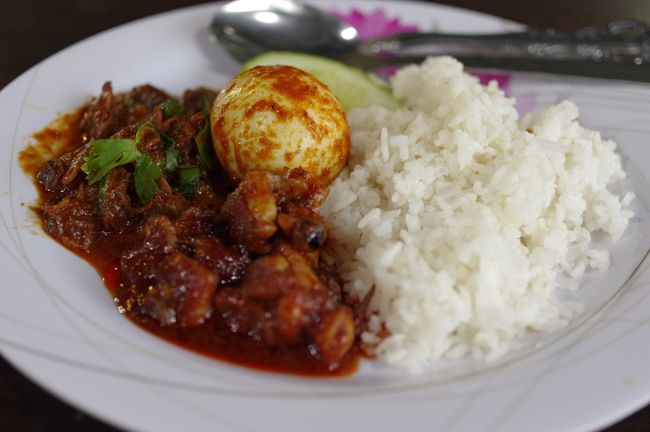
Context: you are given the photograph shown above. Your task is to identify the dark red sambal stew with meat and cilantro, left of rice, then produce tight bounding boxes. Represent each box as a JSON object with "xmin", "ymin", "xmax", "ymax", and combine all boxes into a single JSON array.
[{"xmin": 20, "ymin": 83, "xmax": 359, "ymax": 376}]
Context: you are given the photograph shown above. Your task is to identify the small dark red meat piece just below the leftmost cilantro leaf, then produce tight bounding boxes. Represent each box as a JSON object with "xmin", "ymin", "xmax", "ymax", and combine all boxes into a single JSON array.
[{"xmin": 99, "ymin": 167, "xmax": 133, "ymax": 231}]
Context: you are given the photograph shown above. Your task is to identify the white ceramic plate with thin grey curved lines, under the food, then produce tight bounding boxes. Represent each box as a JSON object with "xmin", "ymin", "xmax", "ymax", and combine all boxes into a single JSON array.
[{"xmin": 0, "ymin": 1, "xmax": 650, "ymax": 432}]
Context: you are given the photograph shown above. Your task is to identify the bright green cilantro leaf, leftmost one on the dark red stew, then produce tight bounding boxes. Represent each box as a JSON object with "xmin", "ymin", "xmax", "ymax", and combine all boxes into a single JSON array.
[{"xmin": 81, "ymin": 138, "xmax": 140, "ymax": 184}]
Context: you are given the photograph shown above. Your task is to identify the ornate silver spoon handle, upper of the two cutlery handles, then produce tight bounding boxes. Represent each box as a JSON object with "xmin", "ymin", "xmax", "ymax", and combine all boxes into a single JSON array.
[{"xmin": 359, "ymin": 20, "xmax": 650, "ymax": 65}]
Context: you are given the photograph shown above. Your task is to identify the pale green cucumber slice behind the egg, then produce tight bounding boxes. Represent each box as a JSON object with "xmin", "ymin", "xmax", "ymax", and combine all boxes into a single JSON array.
[{"xmin": 242, "ymin": 51, "xmax": 402, "ymax": 111}]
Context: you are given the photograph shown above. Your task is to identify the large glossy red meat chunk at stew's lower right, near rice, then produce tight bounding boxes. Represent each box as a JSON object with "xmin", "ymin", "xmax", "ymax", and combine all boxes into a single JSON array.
[{"xmin": 215, "ymin": 242, "xmax": 346, "ymax": 352}]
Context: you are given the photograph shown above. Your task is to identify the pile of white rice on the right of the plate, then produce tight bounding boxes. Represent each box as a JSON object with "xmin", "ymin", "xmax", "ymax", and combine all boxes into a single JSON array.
[{"xmin": 322, "ymin": 57, "xmax": 633, "ymax": 370}]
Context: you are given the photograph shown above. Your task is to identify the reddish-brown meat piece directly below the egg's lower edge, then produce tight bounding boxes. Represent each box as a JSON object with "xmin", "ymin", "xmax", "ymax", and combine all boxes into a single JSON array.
[{"xmin": 221, "ymin": 171, "xmax": 277, "ymax": 254}]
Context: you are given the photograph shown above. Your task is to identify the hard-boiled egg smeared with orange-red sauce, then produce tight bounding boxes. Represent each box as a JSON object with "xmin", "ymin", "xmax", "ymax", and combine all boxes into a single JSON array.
[{"xmin": 210, "ymin": 66, "xmax": 350, "ymax": 185}]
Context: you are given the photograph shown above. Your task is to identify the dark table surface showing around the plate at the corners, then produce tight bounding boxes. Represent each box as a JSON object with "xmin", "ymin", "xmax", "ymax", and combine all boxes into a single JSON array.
[{"xmin": 0, "ymin": 0, "xmax": 650, "ymax": 432}]
